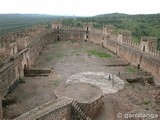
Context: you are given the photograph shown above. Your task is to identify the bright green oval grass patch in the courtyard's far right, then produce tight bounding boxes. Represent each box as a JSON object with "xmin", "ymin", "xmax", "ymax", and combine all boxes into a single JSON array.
[{"xmin": 88, "ymin": 50, "xmax": 112, "ymax": 58}]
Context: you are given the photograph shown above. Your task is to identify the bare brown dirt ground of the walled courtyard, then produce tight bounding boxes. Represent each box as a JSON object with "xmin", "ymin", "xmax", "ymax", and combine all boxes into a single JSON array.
[{"xmin": 3, "ymin": 41, "xmax": 160, "ymax": 120}]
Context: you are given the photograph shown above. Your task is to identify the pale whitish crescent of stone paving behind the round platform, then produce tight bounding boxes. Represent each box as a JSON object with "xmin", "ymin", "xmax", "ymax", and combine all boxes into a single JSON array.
[{"xmin": 66, "ymin": 72, "xmax": 125, "ymax": 94}]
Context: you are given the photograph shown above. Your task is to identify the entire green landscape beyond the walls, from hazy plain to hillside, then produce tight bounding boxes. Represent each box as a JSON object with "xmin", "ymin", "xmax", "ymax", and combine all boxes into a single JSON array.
[{"xmin": 0, "ymin": 13, "xmax": 160, "ymax": 50}]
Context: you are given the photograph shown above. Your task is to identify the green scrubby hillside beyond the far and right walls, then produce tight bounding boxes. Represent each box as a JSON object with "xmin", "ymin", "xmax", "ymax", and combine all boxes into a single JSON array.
[{"xmin": 62, "ymin": 13, "xmax": 160, "ymax": 50}]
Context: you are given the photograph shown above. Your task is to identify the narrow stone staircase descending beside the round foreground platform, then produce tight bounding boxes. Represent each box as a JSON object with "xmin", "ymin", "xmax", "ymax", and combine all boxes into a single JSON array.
[{"xmin": 72, "ymin": 100, "xmax": 92, "ymax": 120}]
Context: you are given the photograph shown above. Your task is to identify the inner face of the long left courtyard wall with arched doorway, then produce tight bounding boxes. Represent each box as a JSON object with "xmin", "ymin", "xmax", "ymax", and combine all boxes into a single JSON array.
[{"xmin": 0, "ymin": 29, "xmax": 56, "ymax": 98}]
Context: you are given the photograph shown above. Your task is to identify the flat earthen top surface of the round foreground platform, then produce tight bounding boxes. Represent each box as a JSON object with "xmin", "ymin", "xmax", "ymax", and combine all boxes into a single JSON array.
[{"xmin": 56, "ymin": 83, "xmax": 103, "ymax": 103}]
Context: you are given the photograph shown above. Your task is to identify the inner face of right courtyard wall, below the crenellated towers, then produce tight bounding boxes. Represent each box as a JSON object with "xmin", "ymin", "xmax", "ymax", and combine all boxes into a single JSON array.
[{"xmin": 104, "ymin": 35, "xmax": 160, "ymax": 85}]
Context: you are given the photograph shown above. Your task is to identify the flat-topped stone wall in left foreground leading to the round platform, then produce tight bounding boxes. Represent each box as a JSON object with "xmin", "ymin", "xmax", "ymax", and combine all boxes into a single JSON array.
[{"xmin": 15, "ymin": 98, "xmax": 72, "ymax": 120}]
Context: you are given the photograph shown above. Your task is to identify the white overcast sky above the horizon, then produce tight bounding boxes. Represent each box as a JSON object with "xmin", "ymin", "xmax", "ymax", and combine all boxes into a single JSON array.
[{"xmin": 0, "ymin": 0, "xmax": 160, "ymax": 16}]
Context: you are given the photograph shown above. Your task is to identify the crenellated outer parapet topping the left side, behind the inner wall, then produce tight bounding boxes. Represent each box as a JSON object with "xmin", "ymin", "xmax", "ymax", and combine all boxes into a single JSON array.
[{"xmin": 0, "ymin": 24, "xmax": 47, "ymax": 57}]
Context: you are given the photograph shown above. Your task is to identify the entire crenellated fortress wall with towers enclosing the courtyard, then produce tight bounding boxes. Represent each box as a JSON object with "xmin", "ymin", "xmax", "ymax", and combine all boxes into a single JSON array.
[{"xmin": 0, "ymin": 22, "xmax": 160, "ymax": 117}]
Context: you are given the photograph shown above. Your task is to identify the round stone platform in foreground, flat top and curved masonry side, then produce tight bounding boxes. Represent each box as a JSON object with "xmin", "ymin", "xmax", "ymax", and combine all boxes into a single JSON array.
[{"xmin": 55, "ymin": 82, "xmax": 104, "ymax": 119}]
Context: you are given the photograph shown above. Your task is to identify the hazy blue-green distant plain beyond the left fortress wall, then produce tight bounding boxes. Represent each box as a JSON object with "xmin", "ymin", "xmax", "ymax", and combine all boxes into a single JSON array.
[{"xmin": 0, "ymin": 14, "xmax": 63, "ymax": 35}]
